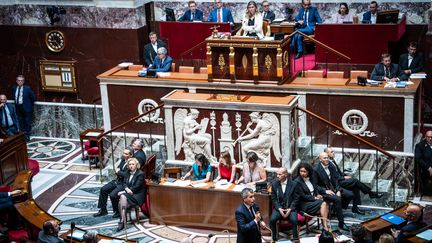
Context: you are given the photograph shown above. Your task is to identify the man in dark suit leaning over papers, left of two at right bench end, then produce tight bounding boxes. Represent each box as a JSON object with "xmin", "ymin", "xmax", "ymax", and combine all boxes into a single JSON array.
[{"xmin": 371, "ymin": 53, "xmax": 408, "ymax": 82}]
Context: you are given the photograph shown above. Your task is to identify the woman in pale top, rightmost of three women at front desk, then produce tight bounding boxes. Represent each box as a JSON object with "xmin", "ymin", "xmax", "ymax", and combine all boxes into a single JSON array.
[{"xmin": 235, "ymin": 152, "xmax": 267, "ymax": 185}]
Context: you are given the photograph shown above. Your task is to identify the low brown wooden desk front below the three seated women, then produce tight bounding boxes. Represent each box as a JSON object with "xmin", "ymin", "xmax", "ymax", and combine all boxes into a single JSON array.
[{"xmin": 149, "ymin": 183, "xmax": 271, "ymax": 231}]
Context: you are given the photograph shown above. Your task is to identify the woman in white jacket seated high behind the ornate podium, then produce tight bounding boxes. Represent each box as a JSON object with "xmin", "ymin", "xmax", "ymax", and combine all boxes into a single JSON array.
[{"xmin": 241, "ymin": 1, "xmax": 264, "ymax": 39}]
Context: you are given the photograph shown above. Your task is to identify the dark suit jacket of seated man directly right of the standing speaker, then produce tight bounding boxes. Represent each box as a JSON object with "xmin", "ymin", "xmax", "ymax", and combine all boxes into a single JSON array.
[{"xmin": 271, "ymin": 180, "xmax": 298, "ymax": 211}]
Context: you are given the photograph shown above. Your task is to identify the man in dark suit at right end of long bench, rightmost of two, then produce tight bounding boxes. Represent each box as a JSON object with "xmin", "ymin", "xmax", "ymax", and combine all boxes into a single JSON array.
[{"xmin": 399, "ymin": 41, "xmax": 423, "ymax": 75}]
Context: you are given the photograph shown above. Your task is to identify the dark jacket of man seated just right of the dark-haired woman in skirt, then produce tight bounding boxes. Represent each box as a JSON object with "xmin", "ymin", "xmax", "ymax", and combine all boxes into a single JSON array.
[{"xmin": 311, "ymin": 162, "xmax": 342, "ymax": 192}]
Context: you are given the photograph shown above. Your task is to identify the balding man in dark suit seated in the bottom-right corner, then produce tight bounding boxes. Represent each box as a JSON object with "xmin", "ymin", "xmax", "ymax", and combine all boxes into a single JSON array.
[{"xmin": 393, "ymin": 204, "xmax": 427, "ymax": 243}]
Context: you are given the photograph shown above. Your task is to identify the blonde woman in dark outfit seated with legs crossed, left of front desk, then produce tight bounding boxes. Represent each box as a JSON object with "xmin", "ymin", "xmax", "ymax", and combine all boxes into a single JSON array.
[{"xmin": 117, "ymin": 158, "xmax": 146, "ymax": 231}]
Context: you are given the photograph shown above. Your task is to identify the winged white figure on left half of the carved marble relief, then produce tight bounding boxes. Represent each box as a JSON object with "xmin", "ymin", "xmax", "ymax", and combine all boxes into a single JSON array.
[{"xmin": 174, "ymin": 109, "xmax": 213, "ymax": 161}]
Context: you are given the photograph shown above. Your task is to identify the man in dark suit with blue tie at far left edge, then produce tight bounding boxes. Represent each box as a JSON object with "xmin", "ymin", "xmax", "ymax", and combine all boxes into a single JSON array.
[{"xmin": 0, "ymin": 94, "xmax": 20, "ymax": 136}]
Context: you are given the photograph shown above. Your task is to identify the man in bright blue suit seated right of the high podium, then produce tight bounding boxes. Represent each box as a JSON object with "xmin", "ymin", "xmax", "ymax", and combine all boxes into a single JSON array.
[{"xmin": 291, "ymin": 0, "xmax": 322, "ymax": 59}]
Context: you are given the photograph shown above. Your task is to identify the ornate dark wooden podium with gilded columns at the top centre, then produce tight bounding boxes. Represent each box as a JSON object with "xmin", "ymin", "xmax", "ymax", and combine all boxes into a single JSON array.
[{"xmin": 206, "ymin": 36, "xmax": 290, "ymax": 85}]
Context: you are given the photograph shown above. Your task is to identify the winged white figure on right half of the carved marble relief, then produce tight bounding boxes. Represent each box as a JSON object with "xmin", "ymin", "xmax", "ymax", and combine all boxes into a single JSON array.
[{"xmin": 237, "ymin": 112, "xmax": 282, "ymax": 167}]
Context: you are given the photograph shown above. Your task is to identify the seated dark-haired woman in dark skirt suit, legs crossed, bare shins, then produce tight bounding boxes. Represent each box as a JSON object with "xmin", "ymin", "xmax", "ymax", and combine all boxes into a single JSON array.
[{"xmin": 296, "ymin": 162, "xmax": 329, "ymax": 230}]
